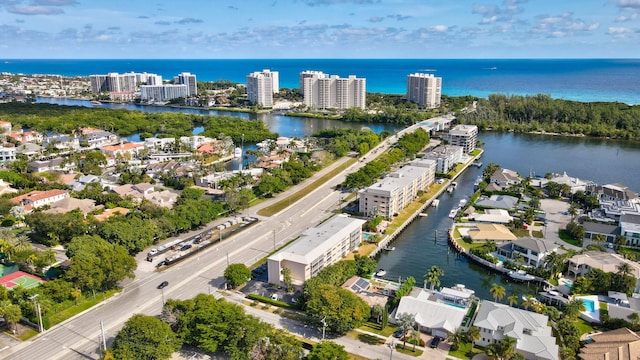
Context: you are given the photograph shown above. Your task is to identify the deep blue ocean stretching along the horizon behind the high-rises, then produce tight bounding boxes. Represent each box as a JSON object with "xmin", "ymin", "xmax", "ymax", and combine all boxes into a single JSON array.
[{"xmin": 0, "ymin": 59, "xmax": 640, "ymax": 104}]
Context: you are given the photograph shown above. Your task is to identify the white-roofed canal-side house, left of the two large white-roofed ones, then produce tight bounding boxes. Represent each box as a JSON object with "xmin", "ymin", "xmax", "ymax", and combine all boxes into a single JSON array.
[{"xmin": 391, "ymin": 290, "xmax": 467, "ymax": 338}]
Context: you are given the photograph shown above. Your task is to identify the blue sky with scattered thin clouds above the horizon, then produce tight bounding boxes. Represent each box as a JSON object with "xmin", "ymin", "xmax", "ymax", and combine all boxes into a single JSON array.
[{"xmin": 0, "ymin": 0, "xmax": 640, "ymax": 59}]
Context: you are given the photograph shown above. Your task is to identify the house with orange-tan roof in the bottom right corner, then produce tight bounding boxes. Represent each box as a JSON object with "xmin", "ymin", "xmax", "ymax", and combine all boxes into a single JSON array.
[{"xmin": 578, "ymin": 328, "xmax": 640, "ymax": 360}]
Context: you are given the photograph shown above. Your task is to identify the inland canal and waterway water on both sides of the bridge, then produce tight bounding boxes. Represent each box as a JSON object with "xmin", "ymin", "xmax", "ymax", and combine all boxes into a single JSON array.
[{"xmin": 38, "ymin": 98, "xmax": 640, "ymax": 301}]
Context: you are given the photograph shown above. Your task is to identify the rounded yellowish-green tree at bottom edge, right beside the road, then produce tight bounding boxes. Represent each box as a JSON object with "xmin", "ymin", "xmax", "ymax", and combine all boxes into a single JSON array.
[{"xmin": 112, "ymin": 314, "xmax": 182, "ymax": 359}]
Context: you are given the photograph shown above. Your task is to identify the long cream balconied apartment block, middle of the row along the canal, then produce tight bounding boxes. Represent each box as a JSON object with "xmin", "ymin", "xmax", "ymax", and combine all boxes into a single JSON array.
[{"xmin": 358, "ymin": 159, "xmax": 436, "ymax": 218}]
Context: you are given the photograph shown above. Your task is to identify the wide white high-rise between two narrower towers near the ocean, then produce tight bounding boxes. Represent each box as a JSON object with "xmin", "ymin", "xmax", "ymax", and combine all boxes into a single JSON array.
[{"xmin": 300, "ymin": 71, "xmax": 367, "ymax": 109}]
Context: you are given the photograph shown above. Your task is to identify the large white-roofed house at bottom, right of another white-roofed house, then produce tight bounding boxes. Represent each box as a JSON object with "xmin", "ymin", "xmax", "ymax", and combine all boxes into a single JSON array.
[{"xmin": 473, "ymin": 300, "xmax": 559, "ymax": 360}]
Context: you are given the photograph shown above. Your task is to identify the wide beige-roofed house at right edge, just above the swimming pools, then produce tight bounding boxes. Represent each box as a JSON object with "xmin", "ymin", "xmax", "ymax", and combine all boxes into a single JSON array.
[{"xmin": 568, "ymin": 251, "xmax": 640, "ymax": 279}]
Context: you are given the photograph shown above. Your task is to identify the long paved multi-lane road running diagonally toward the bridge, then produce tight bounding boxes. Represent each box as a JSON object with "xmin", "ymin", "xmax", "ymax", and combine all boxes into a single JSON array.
[{"xmin": 5, "ymin": 122, "xmax": 430, "ymax": 360}]
